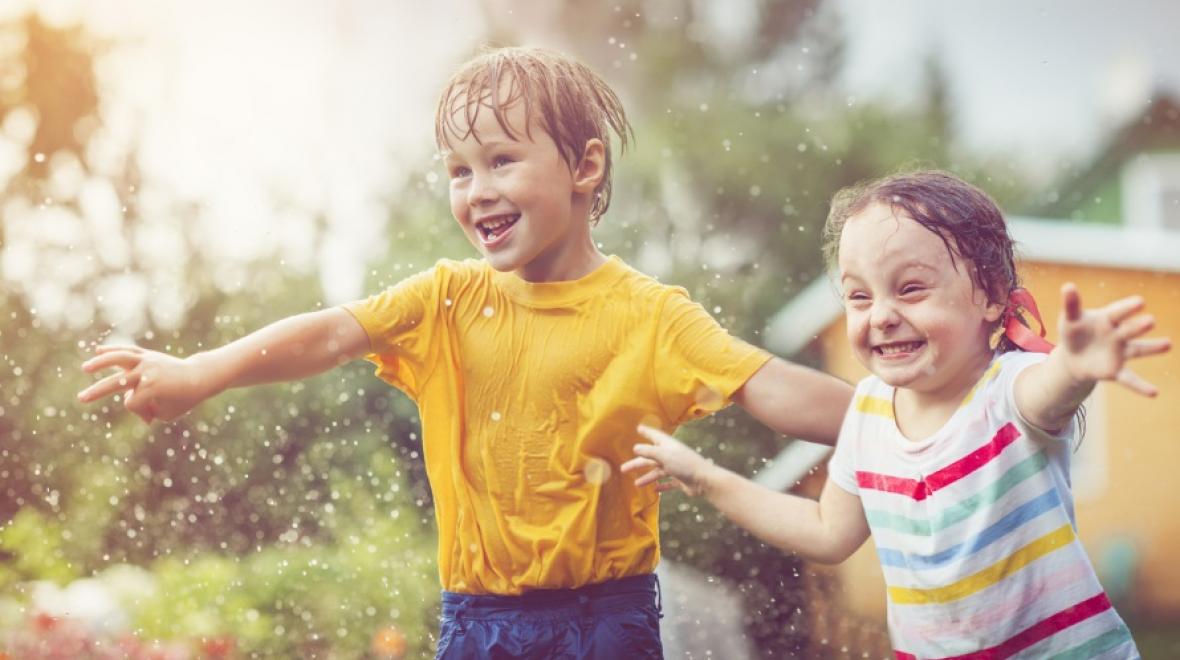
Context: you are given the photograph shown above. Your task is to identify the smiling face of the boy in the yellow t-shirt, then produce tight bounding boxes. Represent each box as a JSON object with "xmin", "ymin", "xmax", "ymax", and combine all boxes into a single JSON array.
[{"xmin": 443, "ymin": 90, "xmax": 603, "ymax": 282}]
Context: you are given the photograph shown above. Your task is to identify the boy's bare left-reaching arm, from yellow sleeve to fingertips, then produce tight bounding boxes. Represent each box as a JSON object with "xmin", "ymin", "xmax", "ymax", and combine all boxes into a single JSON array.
[{"xmin": 78, "ymin": 307, "xmax": 369, "ymax": 422}]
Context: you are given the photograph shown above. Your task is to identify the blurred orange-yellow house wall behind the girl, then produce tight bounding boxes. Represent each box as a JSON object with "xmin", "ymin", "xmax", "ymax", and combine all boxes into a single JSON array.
[{"xmin": 819, "ymin": 262, "xmax": 1180, "ymax": 619}]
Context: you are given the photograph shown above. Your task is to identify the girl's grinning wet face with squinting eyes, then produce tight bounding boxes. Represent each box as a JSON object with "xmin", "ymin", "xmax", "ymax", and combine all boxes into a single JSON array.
[{"xmin": 838, "ymin": 203, "xmax": 1003, "ymax": 398}]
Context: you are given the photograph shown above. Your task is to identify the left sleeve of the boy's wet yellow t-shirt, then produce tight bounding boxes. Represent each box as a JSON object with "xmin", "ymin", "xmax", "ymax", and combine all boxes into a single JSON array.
[{"xmin": 343, "ymin": 267, "xmax": 438, "ymax": 398}]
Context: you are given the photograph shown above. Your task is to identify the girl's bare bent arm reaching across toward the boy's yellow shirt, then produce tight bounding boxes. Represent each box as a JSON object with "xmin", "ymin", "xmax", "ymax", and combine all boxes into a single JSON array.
[{"xmin": 622, "ymin": 426, "xmax": 868, "ymax": 563}]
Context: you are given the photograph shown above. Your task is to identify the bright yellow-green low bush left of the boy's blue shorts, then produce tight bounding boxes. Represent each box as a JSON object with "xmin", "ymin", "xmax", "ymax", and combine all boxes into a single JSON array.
[{"xmin": 135, "ymin": 467, "xmax": 438, "ymax": 658}]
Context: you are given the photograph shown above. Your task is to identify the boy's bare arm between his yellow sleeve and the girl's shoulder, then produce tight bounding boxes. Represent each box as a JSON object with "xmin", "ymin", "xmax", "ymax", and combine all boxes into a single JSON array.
[{"xmin": 733, "ymin": 358, "xmax": 852, "ymax": 445}]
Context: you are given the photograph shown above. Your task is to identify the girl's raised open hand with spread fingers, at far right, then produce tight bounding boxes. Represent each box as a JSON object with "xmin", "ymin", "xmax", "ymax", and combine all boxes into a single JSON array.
[{"xmin": 1058, "ymin": 282, "xmax": 1172, "ymax": 397}]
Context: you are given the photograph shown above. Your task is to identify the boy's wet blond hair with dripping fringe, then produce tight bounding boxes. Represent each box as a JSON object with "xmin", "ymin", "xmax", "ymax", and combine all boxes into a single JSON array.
[{"xmin": 434, "ymin": 47, "xmax": 635, "ymax": 222}]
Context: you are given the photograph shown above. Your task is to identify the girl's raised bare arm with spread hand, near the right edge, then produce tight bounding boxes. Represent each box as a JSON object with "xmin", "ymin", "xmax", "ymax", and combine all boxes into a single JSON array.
[{"xmin": 1014, "ymin": 282, "xmax": 1172, "ymax": 431}]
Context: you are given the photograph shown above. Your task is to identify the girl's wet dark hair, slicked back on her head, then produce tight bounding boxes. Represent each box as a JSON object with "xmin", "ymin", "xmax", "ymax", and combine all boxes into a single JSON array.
[{"xmin": 822, "ymin": 170, "xmax": 1020, "ymax": 351}]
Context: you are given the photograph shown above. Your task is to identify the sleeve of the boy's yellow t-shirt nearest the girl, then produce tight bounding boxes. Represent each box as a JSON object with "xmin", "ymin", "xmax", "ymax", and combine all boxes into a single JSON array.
[{"xmin": 653, "ymin": 288, "xmax": 772, "ymax": 424}]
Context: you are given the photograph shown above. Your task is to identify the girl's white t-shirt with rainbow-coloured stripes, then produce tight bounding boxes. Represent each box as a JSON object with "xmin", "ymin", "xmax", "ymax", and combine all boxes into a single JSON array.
[{"xmin": 828, "ymin": 352, "xmax": 1139, "ymax": 659}]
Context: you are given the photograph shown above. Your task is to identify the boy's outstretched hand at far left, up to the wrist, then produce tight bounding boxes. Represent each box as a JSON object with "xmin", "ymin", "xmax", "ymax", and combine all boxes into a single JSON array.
[{"xmin": 78, "ymin": 346, "xmax": 217, "ymax": 423}]
